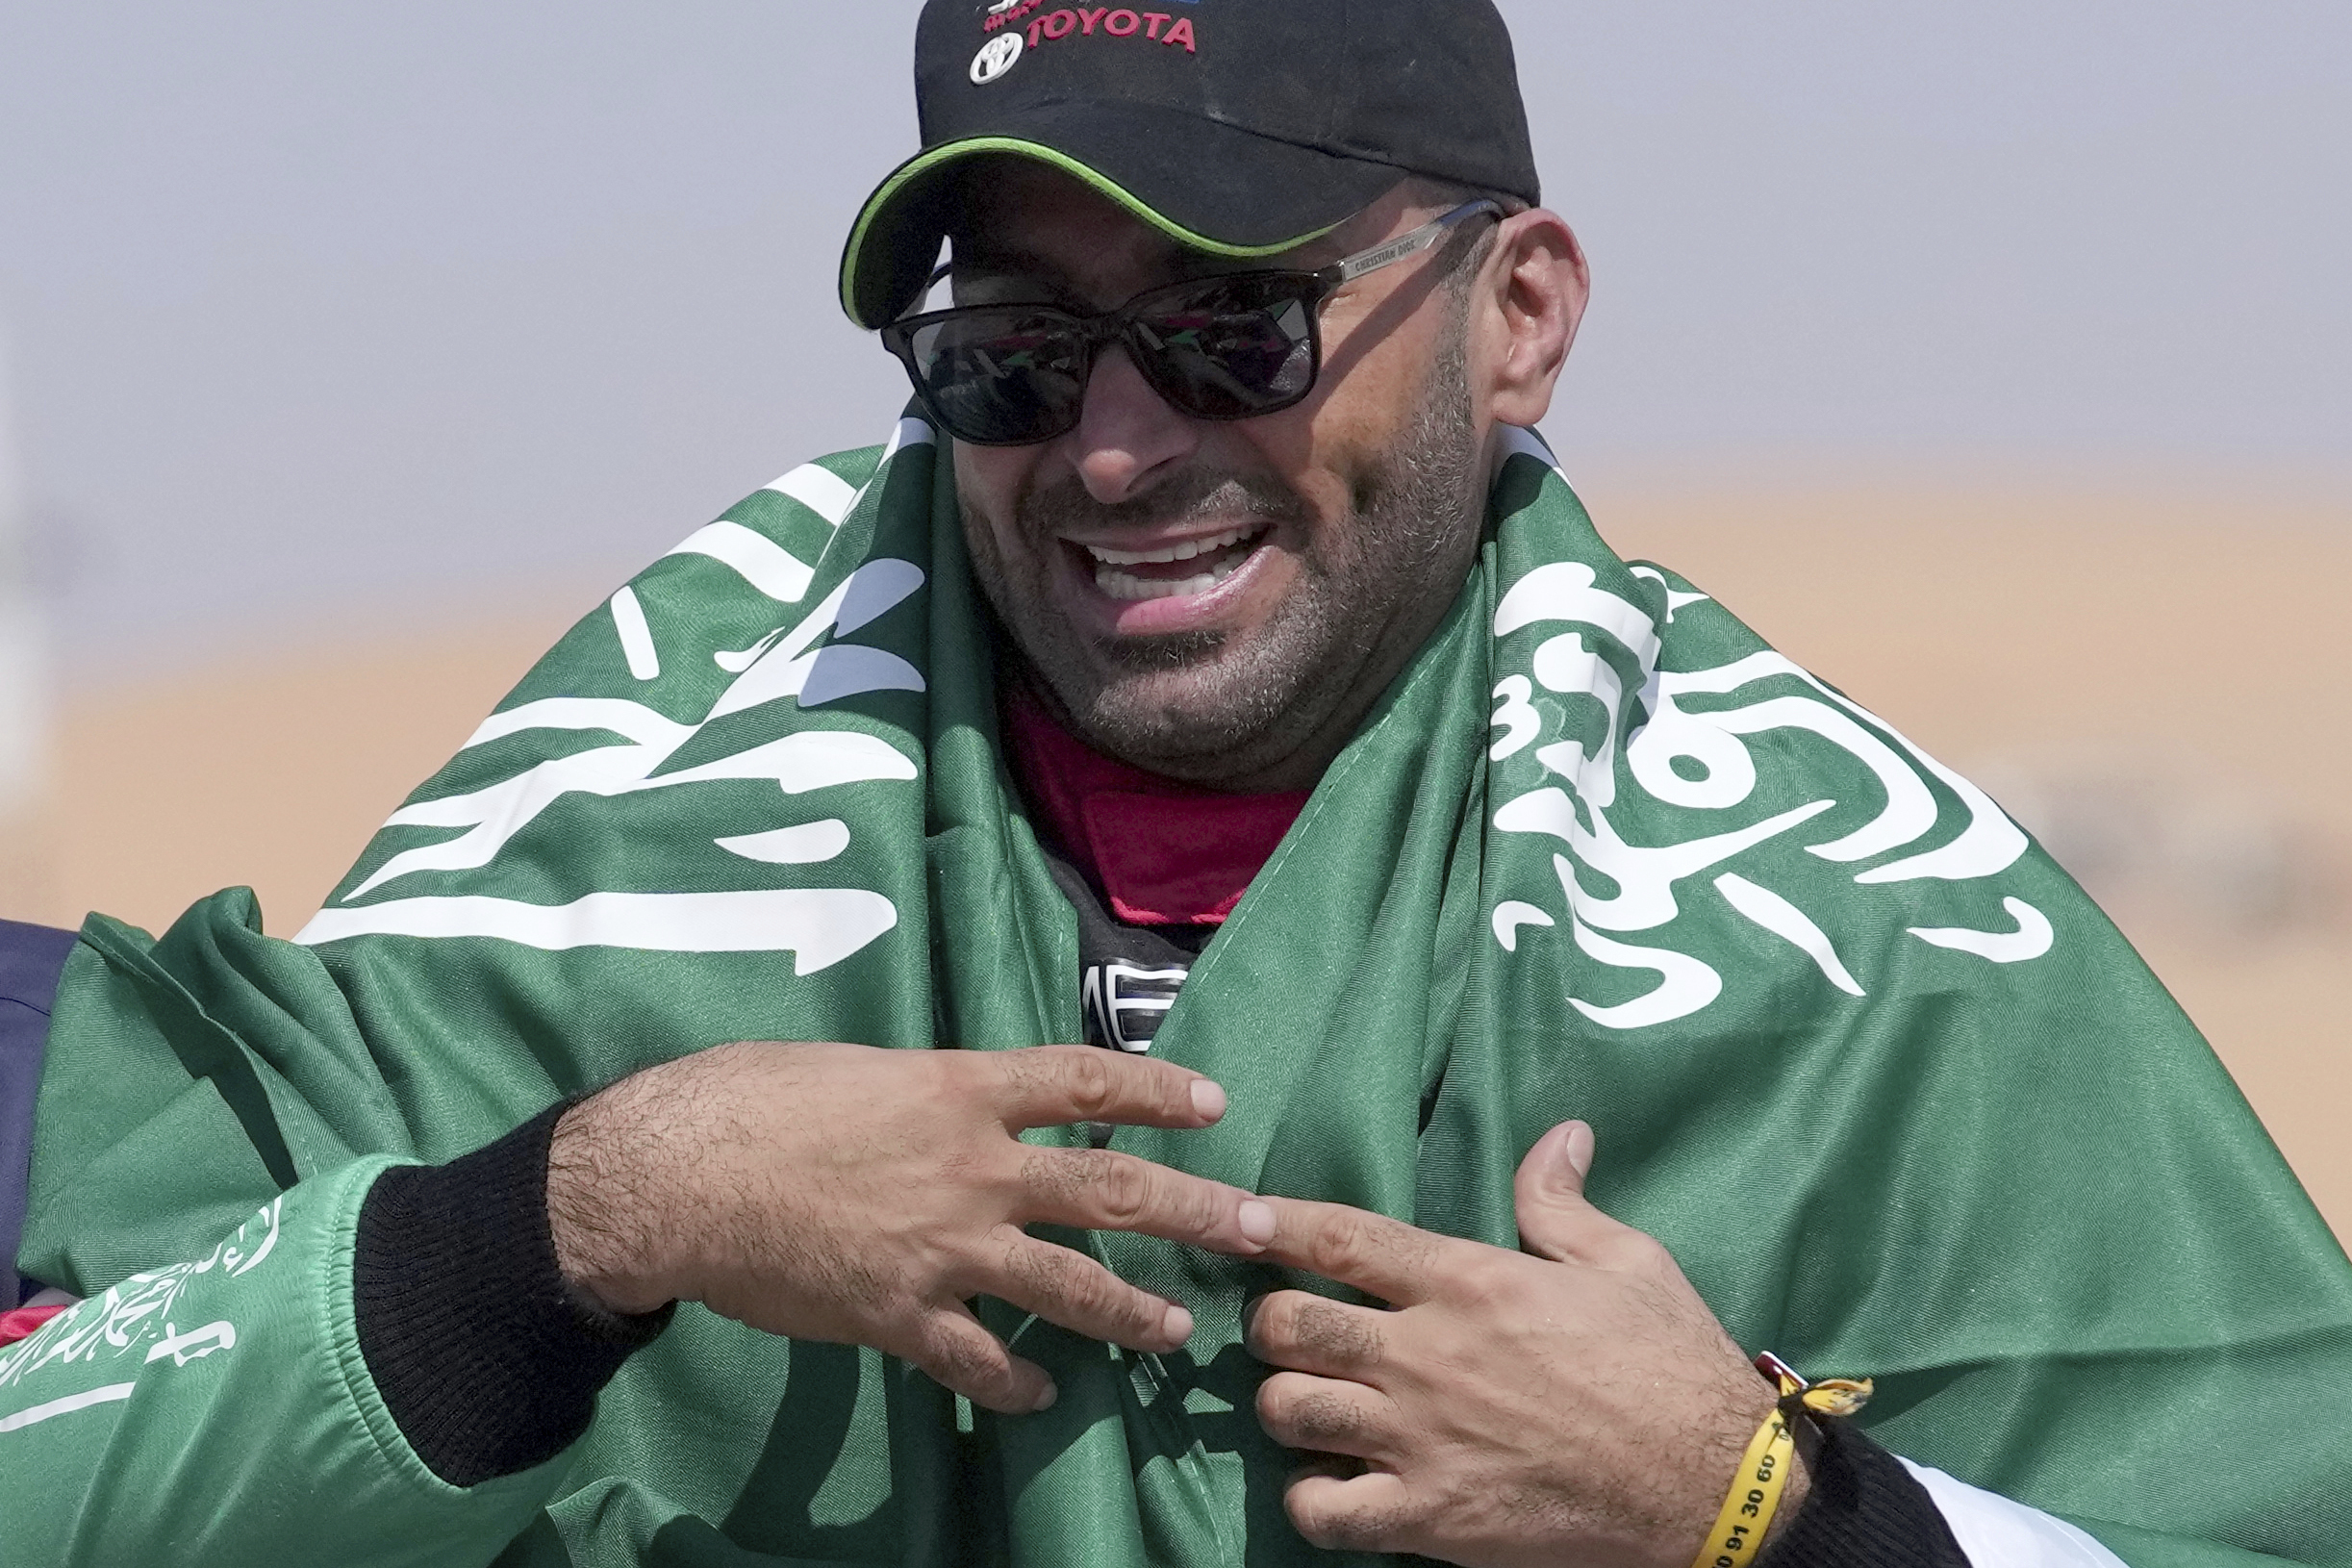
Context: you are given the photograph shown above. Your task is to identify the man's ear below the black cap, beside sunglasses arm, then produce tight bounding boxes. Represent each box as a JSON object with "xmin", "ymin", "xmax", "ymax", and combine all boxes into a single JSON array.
[{"xmin": 1470, "ymin": 207, "xmax": 1592, "ymax": 425}]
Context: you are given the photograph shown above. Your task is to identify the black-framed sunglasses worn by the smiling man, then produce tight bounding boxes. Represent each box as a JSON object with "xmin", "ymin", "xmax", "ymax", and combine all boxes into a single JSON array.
[{"xmin": 882, "ymin": 202, "xmax": 1503, "ymax": 446}]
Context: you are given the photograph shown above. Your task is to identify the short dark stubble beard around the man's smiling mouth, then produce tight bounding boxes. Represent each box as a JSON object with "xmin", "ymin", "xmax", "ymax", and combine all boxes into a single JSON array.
[{"xmin": 964, "ymin": 319, "xmax": 1481, "ymax": 783}]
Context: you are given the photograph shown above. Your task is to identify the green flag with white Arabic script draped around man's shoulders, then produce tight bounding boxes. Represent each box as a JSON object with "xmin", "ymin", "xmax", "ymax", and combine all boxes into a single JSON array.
[{"xmin": 0, "ymin": 420, "xmax": 2352, "ymax": 1568}]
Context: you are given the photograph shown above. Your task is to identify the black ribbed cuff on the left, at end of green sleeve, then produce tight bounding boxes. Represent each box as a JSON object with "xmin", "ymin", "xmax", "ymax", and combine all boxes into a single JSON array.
[{"xmin": 350, "ymin": 1105, "xmax": 675, "ymax": 1485}]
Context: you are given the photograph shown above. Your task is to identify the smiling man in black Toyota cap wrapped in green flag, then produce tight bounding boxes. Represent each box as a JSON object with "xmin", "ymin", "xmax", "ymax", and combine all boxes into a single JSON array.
[{"xmin": 0, "ymin": 0, "xmax": 2352, "ymax": 1568}]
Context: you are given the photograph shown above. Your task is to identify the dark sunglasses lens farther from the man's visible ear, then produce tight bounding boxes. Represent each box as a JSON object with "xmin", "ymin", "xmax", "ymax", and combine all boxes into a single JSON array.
[{"xmin": 905, "ymin": 308, "xmax": 1087, "ymax": 446}]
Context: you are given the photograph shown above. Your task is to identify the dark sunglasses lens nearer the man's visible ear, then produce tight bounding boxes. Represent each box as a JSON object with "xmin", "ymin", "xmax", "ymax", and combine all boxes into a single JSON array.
[{"xmin": 1133, "ymin": 275, "xmax": 1315, "ymax": 418}]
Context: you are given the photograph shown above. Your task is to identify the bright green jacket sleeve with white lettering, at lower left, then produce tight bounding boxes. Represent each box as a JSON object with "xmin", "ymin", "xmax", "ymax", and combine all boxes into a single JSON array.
[{"xmin": 0, "ymin": 1156, "xmax": 565, "ymax": 1568}]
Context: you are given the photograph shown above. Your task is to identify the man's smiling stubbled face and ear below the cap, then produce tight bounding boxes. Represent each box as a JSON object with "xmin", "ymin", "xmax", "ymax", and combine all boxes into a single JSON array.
[{"xmin": 926, "ymin": 155, "xmax": 1496, "ymax": 790}]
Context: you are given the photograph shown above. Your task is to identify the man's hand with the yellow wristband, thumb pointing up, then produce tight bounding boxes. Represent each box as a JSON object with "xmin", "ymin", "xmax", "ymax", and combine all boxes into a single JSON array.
[{"xmin": 1249, "ymin": 1122, "xmax": 1778, "ymax": 1568}]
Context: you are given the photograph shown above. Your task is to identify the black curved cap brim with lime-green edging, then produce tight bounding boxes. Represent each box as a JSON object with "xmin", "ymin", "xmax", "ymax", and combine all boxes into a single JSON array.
[{"xmin": 842, "ymin": 104, "xmax": 1406, "ymax": 329}]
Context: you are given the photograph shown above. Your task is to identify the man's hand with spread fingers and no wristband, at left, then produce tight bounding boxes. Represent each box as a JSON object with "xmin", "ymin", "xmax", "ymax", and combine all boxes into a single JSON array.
[{"xmin": 548, "ymin": 1044, "xmax": 1273, "ymax": 1413}]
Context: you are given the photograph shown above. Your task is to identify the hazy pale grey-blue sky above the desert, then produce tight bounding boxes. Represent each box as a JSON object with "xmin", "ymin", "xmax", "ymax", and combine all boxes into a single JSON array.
[{"xmin": 0, "ymin": 0, "xmax": 2352, "ymax": 679}]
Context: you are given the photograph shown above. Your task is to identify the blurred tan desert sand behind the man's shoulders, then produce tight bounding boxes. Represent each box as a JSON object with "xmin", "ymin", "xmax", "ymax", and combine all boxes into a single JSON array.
[{"xmin": 0, "ymin": 477, "xmax": 2352, "ymax": 1234}]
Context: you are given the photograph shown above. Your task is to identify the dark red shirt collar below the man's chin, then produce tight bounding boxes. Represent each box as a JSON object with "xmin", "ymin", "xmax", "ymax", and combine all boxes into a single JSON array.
[{"xmin": 1004, "ymin": 682, "xmax": 1307, "ymax": 926}]
